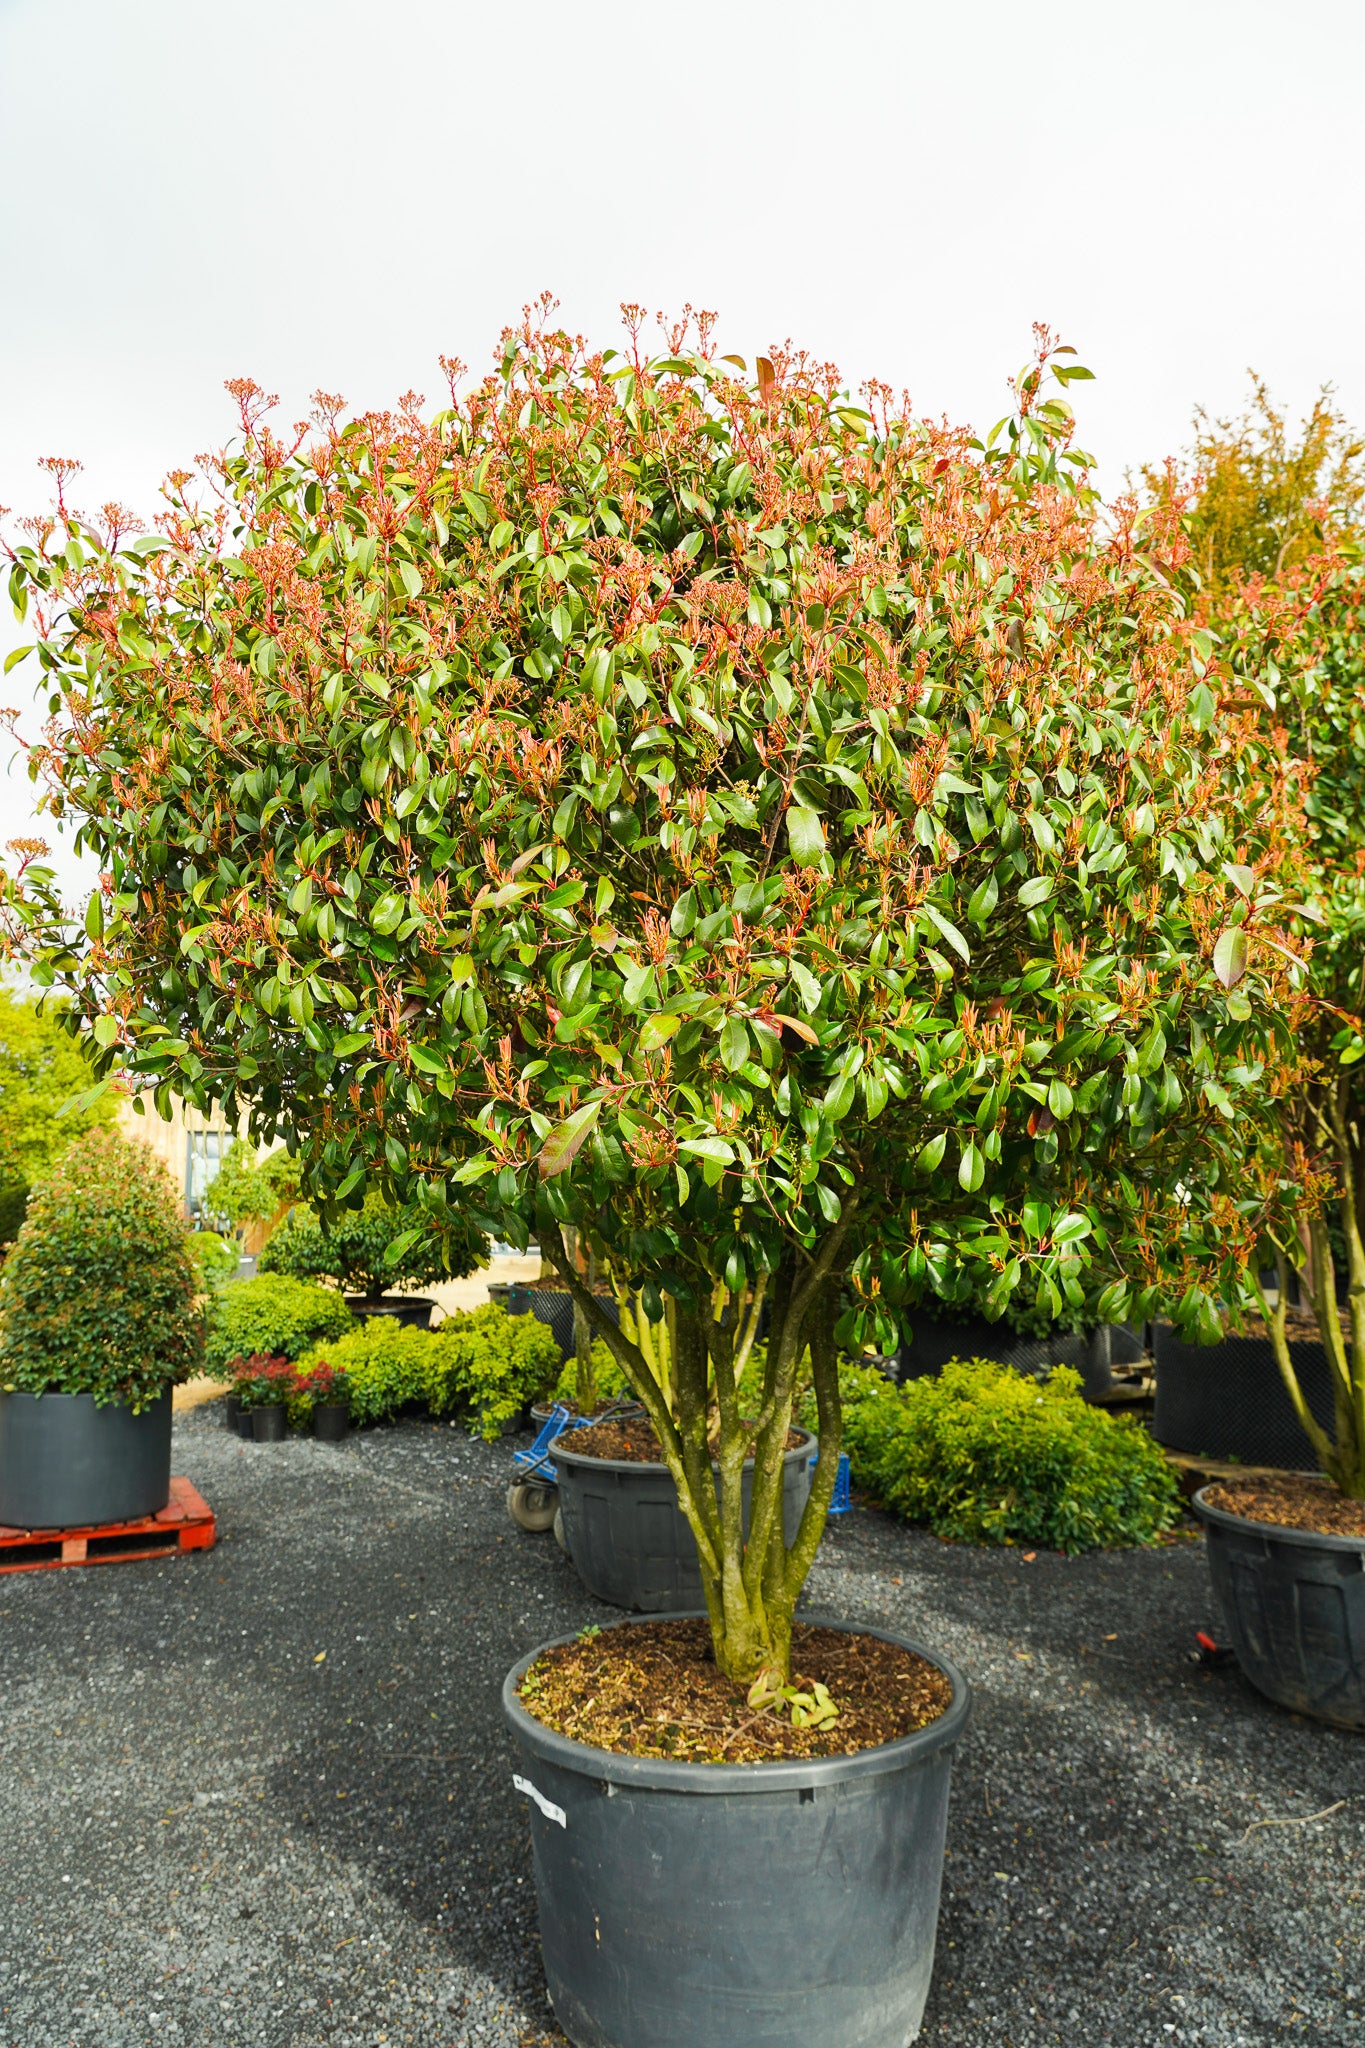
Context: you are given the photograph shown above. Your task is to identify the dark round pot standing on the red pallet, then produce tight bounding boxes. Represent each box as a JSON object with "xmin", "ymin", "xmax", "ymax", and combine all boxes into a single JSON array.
[{"xmin": 0, "ymin": 1386, "xmax": 170, "ymax": 1530}]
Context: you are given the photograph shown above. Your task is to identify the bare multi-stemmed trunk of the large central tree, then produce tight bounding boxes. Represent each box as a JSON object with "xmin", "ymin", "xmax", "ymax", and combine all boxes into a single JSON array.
[{"xmin": 553, "ymin": 1217, "xmax": 847, "ymax": 1686}]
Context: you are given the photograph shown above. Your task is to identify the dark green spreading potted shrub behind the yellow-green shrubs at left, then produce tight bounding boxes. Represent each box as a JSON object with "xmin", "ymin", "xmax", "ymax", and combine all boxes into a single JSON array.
[{"xmin": 256, "ymin": 1194, "xmax": 487, "ymax": 1329}]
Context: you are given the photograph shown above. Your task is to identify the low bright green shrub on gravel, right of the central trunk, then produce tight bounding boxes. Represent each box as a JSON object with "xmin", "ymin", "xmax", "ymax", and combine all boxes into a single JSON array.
[{"xmin": 843, "ymin": 1358, "xmax": 1181, "ymax": 1550}]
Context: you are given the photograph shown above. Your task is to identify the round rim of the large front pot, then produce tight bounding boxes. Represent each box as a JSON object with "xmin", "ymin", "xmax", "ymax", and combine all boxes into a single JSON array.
[{"xmin": 501, "ymin": 1610, "xmax": 972, "ymax": 1794}]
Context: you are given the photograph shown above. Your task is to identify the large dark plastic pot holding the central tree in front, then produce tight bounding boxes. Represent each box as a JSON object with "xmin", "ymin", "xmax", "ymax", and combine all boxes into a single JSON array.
[{"xmin": 503, "ymin": 1622, "xmax": 970, "ymax": 2048}]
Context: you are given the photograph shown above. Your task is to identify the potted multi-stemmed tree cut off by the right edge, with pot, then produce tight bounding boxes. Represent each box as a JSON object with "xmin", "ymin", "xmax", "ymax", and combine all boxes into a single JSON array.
[{"xmin": 1158, "ymin": 549, "xmax": 1365, "ymax": 1729}]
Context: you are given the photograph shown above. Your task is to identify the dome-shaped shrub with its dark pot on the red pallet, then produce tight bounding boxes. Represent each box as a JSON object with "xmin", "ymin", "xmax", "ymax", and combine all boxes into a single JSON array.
[{"xmin": 0, "ymin": 1130, "xmax": 203, "ymax": 1528}]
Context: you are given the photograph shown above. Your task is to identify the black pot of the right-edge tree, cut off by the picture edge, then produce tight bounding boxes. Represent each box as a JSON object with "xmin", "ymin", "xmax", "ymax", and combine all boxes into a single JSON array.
[{"xmin": 1193, "ymin": 1487, "xmax": 1365, "ymax": 1735}]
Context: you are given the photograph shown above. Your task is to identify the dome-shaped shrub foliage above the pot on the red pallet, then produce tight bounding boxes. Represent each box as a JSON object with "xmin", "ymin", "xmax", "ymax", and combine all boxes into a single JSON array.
[{"xmin": 0, "ymin": 1130, "xmax": 205, "ymax": 1413}]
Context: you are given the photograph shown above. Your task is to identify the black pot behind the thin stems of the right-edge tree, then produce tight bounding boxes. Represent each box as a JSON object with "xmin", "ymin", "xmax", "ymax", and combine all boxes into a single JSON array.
[{"xmin": 1152, "ymin": 1323, "xmax": 1332, "ymax": 1473}]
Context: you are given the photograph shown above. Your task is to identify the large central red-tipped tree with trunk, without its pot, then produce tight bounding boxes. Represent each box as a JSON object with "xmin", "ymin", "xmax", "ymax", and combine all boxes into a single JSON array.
[{"xmin": 4, "ymin": 305, "xmax": 1293, "ymax": 1679}]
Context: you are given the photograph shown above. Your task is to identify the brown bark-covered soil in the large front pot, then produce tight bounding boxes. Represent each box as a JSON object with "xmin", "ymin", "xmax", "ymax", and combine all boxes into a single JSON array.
[{"xmin": 520, "ymin": 1620, "xmax": 952, "ymax": 1763}]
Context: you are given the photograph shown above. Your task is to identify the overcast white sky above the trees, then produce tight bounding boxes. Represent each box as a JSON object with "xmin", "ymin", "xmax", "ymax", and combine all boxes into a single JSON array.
[{"xmin": 0, "ymin": 0, "xmax": 1365, "ymax": 897}]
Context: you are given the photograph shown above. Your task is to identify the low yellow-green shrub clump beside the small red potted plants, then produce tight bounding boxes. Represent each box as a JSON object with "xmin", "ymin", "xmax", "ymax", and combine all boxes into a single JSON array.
[{"xmin": 299, "ymin": 1303, "xmax": 559, "ymax": 1442}]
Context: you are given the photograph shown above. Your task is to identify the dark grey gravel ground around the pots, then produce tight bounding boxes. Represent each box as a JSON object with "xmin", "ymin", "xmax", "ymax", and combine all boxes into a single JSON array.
[{"xmin": 0, "ymin": 1409, "xmax": 1365, "ymax": 2048}]
